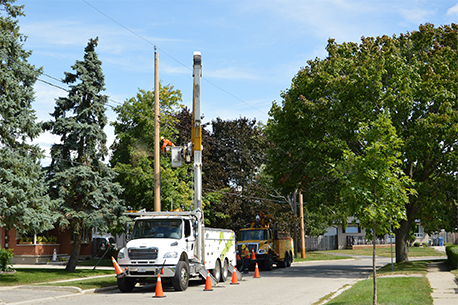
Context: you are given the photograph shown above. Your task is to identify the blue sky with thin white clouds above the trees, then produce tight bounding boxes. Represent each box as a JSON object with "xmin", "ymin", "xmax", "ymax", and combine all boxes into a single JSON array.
[{"xmin": 10, "ymin": 0, "xmax": 458, "ymax": 163}]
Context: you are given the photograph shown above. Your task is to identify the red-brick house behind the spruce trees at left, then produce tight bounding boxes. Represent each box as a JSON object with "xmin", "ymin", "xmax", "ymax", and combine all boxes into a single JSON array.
[{"xmin": 0, "ymin": 227, "xmax": 94, "ymax": 264}]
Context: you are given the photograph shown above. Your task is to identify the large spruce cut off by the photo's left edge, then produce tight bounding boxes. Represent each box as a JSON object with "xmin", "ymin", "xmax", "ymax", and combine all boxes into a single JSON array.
[{"xmin": 0, "ymin": 0, "xmax": 55, "ymax": 233}]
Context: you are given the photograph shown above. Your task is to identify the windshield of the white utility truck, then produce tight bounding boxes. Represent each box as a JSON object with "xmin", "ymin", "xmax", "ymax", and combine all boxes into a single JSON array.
[{"xmin": 132, "ymin": 219, "xmax": 182, "ymax": 239}]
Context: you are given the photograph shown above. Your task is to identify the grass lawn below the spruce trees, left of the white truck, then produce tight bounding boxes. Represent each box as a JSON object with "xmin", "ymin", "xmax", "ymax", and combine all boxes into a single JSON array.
[{"xmin": 0, "ymin": 268, "xmax": 116, "ymax": 288}]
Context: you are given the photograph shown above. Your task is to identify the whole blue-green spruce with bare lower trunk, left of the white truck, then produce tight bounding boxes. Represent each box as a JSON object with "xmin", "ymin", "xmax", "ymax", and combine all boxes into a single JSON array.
[{"xmin": 44, "ymin": 38, "xmax": 126, "ymax": 272}]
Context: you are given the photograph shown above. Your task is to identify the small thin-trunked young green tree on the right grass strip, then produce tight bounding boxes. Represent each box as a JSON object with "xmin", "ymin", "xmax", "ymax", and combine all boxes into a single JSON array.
[{"xmin": 336, "ymin": 114, "xmax": 415, "ymax": 305}]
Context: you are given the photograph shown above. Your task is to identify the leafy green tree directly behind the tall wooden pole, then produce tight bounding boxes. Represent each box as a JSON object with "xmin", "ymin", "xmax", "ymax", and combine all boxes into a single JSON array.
[{"xmin": 110, "ymin": 85, "xmax": 193, "ymax": 210}]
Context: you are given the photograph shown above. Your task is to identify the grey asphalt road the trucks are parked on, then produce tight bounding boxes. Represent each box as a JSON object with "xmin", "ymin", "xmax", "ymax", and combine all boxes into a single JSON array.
[{"xmin": 0, "ymin": 258, "xmax": 398, "ymax": 305}]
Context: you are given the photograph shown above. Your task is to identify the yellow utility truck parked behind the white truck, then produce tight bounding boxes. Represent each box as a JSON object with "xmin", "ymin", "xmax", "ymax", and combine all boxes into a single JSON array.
[{"xmin": 237, "ymin": 212, "xmax": 294, "ymax": 270}]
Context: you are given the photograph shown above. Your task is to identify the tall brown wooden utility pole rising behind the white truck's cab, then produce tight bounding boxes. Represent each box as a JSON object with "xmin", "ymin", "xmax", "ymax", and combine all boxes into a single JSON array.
[{"xmin": 154, "ymin": 46, "xmax": 161, "ymax": 212}]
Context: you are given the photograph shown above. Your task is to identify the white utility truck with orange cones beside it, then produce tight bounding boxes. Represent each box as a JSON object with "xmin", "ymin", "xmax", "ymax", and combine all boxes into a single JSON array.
[{"xmin": 118, "ymin": 210, "xmax": 237, "ymax": 292}]
